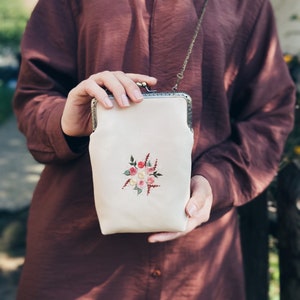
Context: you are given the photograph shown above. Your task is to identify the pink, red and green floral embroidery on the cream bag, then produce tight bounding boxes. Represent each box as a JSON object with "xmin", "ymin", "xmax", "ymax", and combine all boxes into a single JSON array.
[{"xmin": 122, "ymin": 153, "xmax": 162, "ymax": 196}]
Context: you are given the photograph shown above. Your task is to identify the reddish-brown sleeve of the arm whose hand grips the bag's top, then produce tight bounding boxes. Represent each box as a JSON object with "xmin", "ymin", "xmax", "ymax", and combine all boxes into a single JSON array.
[{"xmin": 14, "ymin": 1, "xmax": 80, "ymax": 163}]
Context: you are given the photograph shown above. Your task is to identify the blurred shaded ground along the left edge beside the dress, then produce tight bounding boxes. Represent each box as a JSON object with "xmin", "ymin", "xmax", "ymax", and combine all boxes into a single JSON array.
[{"xmin": 0, "ymin": 116, "xmax": 43, "ymax": 300}]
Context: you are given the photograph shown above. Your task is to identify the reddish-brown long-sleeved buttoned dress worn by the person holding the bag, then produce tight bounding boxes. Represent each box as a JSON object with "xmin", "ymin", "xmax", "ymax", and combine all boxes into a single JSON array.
[{"xmin": 14, "ymin": 0, "xmax": 294, "ymax": 300}]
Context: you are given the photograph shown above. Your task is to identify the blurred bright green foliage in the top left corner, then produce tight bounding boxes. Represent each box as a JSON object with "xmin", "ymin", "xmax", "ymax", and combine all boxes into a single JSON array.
[{"xmin": 0, "ymin": 0, "xmax": 29, "ymax": 50}]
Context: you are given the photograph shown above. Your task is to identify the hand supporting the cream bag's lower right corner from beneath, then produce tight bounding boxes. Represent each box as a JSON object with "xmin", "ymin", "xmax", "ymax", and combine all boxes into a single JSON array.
[{"xmin": 148, "ymin": 175, "xmax": 213, "ymax": 243}]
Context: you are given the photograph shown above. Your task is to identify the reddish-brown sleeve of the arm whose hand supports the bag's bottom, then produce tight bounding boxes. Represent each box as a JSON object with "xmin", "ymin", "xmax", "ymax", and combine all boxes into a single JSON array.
[{"xmin": 193, "ymin": 1, "xmax": 295, "ymax": 210}]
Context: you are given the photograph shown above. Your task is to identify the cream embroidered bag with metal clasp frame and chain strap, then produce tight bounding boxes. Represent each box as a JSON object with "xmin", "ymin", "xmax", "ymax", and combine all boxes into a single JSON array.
[{"xmin": 89, "ymin": 0, "xmax": 207, "ymax": 234}]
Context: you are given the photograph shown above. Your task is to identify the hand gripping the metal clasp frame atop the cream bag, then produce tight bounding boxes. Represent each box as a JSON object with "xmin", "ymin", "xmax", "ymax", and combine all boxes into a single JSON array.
[{"xmin": 61, "ymin": 71, "xmax": 157, "ymax": 137}]
